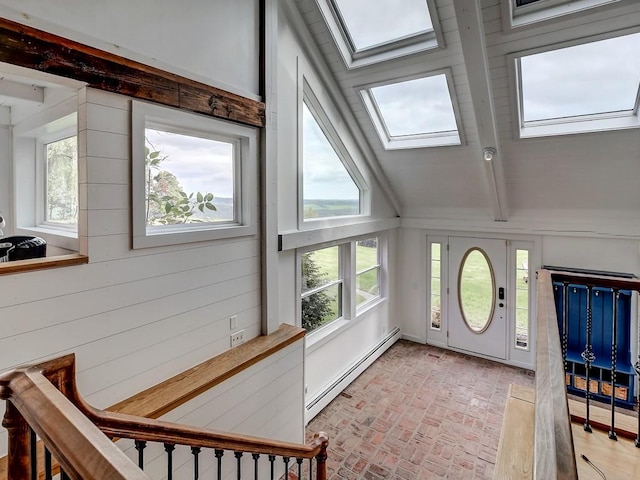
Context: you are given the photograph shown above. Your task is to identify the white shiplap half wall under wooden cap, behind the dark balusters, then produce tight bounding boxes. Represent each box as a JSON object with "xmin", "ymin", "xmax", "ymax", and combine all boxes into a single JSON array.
[{"xmin": 118, "ymin": 340, "xmax": 304, "ymax": 479}]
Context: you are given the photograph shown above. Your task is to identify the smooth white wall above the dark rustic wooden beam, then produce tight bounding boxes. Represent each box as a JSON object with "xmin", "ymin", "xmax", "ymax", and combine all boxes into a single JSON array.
[{"xmin": 0, "ymin": 0, "xmax": 260, "ymax": 98}]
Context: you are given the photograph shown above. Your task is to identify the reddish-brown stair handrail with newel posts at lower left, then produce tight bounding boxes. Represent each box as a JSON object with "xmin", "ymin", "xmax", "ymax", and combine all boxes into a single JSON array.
[{"xmin": 0, "ymin": 354, "xmax": 328, "ymax": 480}]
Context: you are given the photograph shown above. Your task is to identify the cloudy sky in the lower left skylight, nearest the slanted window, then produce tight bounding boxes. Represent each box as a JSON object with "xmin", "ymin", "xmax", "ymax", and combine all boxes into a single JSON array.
[{"xmin": 371, "ymin": 75, "xmax": 457, "ymax": 137}]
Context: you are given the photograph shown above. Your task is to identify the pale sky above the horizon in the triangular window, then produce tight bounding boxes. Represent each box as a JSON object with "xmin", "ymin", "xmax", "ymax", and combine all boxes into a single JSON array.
[{"xmin": 302, "ymin": 104, "xmax": 360, "ymax": 200}]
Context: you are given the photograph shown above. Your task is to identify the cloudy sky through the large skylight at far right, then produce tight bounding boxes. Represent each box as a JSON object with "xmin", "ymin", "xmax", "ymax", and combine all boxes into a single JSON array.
[{"xmin": 520, "ymin": 33, "xmax": 640, "ymax": 121}]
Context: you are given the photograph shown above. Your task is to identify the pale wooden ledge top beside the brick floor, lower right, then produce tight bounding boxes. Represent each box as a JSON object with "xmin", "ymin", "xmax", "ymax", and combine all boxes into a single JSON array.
[{"xmin": 493, "ymin": 385, "xmax": 535, "ymax": 480}]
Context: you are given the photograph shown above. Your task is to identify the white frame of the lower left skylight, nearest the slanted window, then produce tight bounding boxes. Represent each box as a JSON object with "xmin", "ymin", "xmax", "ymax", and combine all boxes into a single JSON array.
[{"xmin": 355, "ymin": 69, "xmax": 465, "ymax": 150}]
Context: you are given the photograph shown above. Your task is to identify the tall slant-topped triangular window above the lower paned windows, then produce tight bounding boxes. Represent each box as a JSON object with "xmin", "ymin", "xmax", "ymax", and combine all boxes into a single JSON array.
[{"xmin": 302, "ymin": 101, "xmax": 363, "ymax": 221}]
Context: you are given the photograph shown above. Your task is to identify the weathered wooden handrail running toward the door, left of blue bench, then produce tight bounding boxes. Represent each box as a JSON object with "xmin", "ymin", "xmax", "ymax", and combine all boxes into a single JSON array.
[{"xmin": 533, "ymin": 270, "xmax": 578, "ymax": 480}]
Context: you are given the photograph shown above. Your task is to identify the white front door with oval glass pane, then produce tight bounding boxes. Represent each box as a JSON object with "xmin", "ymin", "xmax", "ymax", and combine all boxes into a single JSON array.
[{"xmin": 447, "ymin": 237, "xmax": 507, "ymax": 360}]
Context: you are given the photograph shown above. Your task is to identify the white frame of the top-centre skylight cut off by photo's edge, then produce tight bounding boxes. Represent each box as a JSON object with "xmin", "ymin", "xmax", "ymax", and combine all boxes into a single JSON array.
[{"xmin": 316, "ymin": 0, "xmax": 445, "ymax": 69}]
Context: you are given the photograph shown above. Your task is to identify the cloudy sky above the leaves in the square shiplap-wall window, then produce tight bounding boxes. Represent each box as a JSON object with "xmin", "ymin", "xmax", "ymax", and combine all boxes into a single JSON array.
[{"xmin": 145, "ymin": 128, "xmax": 233, "ymax": 198}]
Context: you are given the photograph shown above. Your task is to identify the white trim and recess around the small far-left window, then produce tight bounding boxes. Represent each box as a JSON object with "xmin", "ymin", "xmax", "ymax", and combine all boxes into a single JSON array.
[{"xmin": 13, "ymin": 99, "xmax": 82, "ymax": 252}]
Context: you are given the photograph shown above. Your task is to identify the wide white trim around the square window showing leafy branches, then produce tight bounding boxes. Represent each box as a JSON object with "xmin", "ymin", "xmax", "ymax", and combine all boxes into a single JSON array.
[{"xmin": 131, "ymin": 101, "xmax": 258, "ymax": 249}]
